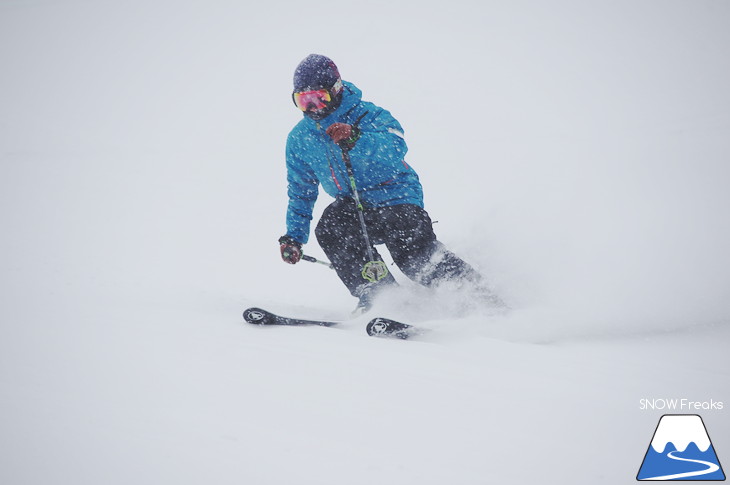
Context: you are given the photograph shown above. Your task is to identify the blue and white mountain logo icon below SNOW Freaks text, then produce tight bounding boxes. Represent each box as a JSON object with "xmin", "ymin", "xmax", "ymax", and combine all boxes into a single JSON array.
[{"xmin": 636, "ymin": 414, "xmax": 725, "ymax": 481}]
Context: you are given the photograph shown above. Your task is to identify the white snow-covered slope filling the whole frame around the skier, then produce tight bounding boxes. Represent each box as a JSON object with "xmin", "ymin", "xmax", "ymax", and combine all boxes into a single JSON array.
[{"xmin": 0, "ymin": 0, "xmax": 730, "ymax": 485}]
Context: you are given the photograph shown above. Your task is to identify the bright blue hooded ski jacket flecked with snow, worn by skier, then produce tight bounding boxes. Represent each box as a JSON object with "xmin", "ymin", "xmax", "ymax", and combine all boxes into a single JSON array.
[{"xmin": 286, "ymin": 81, "xmax": 423, "ymax": 244}]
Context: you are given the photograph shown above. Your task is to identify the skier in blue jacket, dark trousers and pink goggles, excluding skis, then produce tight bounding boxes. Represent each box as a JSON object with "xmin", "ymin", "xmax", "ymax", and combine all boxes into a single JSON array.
[{"xmin": 279, "ymin": 54, "xmax": 494, "ymax": 313}]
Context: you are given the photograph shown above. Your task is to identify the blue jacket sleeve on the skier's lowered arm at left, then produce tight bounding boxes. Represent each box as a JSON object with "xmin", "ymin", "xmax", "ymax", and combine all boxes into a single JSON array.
[{"xmin": 286, "ymin": 135, "xmax": 319, "ymax": 244}]
